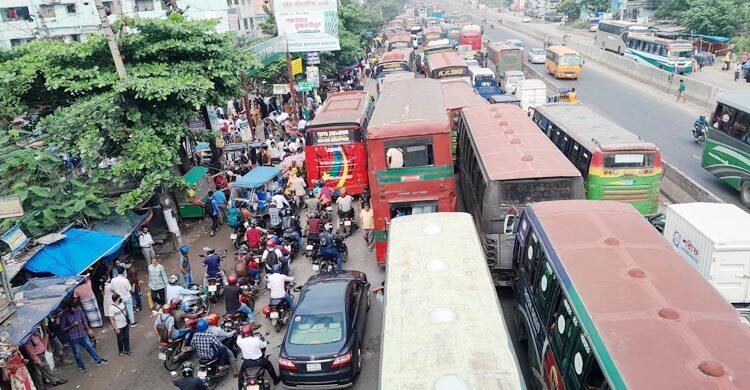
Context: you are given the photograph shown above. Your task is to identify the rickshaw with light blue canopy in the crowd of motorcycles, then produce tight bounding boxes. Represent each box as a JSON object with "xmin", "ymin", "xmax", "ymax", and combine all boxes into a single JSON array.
[{"xmin": 229, "ymin": 167, "xmax": 283, "ymax": 227}]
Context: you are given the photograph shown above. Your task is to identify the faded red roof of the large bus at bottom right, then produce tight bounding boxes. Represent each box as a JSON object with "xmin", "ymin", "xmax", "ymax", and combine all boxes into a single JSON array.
[{"xmin": 527, "ymin": 200, "xmax": 750, "ymax": 389}]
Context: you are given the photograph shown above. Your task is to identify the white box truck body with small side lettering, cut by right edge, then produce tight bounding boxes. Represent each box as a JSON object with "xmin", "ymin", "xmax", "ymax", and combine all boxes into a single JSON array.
[{"xmin": 664, "ymin": 203, "xmax": 750, "ymax": 307}]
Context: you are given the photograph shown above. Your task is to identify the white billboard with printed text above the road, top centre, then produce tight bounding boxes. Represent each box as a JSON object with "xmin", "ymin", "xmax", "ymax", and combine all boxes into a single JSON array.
[{"xmin": 273, "ymin": 0, "xmax": 341, "ymax": 53}]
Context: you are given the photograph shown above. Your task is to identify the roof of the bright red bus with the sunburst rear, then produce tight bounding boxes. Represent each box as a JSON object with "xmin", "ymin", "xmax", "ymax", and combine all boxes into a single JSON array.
[{"xmin": 307, "ymin": 91, "xmax": 370, "ymax": 131}]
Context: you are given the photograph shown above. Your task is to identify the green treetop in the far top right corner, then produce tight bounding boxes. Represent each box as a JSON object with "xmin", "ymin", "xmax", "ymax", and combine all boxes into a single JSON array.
[{"xmin": 679, "ymin": 0, "xmax": 743, "ymax": 37}]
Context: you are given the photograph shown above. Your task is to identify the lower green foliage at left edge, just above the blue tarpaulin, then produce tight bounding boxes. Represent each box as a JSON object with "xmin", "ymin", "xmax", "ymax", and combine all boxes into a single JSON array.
[{"xmin": 0, "ymin": 129, "xmax": 110, "ymax": 237}]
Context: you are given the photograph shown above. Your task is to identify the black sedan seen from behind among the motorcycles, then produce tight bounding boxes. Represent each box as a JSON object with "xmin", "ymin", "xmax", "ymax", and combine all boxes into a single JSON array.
[{"xmin": 279, "ymin": 271, "xmax": 370, "ymax": 389}]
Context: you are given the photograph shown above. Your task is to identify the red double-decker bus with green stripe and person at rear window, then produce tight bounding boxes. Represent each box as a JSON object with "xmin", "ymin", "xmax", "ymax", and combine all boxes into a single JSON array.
[{"xmin": 367, "ymin": 79, "xmax": 456, "ymax": 264}]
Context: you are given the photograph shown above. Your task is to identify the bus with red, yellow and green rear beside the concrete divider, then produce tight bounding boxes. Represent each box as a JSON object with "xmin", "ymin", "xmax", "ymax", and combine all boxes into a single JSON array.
[{"xmin": 534, "ymin": 103, "xmax": 662, "ymax": 215}]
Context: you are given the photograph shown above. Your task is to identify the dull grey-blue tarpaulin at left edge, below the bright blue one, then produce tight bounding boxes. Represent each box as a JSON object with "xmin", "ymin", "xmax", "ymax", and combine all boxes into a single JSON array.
[{"xmin": 0, "ymin": 276, "xmax": 84, "ymax": 346}]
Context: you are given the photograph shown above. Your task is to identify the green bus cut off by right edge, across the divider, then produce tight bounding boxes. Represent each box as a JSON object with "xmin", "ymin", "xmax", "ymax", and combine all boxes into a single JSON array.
[{"xmin": 701, "ymin": 91, "xmax": 750, "ymax": 207}]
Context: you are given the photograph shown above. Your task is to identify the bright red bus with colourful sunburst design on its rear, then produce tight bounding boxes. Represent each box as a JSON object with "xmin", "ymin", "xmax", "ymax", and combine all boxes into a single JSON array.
[{"xmin": 305, "ymin": 91, "xmax": 374, "ymax": 195}]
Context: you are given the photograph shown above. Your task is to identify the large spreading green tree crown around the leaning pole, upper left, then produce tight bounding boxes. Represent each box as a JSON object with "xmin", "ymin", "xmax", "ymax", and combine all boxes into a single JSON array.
[{"xmin": 0, "ymin": 13, "xmax": 254, "ymax": 224}]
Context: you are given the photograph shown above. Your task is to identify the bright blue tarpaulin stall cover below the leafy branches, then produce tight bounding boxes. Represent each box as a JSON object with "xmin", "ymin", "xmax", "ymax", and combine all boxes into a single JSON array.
[{"xmin": 26, "ymin": 229, "xmax": 125, "ymax": 276}]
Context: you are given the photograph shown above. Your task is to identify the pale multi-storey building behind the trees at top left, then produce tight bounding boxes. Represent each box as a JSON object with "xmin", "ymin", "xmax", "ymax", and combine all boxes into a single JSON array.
[{"xmin": 0, "ymin": 0, "xmax": 256, "ymax": 48}]
